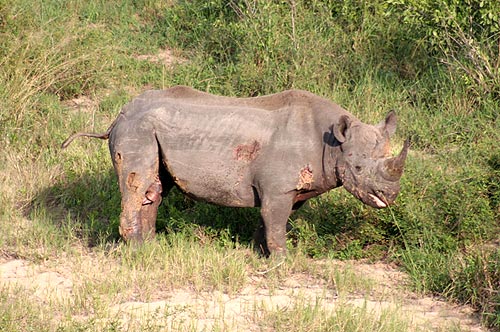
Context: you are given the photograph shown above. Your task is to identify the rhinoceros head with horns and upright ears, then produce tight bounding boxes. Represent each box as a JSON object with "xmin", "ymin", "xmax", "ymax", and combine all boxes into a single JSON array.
[{"xmin": 334, "ymin": 111, "xmax": 409, "ymax": 208}]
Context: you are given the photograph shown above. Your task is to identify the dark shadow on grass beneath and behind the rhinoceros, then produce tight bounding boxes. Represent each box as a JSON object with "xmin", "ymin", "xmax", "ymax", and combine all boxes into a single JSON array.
[{"xmin": 25, "ymin": 168, "xmax": 260, "ymax": 246}]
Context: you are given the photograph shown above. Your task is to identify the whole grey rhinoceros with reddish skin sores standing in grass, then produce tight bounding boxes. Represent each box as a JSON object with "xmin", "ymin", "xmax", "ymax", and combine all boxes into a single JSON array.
[{"xmin": 62, "ymin": 86, "xmax": 409, "ymax": 255}]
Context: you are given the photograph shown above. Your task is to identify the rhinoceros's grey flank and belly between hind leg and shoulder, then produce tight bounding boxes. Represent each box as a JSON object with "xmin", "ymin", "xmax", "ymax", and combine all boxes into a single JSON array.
[{"xmin": 152, "ymin": 107, "xmax": 272, "ymax": 207}]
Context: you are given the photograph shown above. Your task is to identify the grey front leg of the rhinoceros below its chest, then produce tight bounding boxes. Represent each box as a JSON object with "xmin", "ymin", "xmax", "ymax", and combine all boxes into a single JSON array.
[{"xmin": 256, "ymin": 196, "xmax": 293, "ymax": 256}]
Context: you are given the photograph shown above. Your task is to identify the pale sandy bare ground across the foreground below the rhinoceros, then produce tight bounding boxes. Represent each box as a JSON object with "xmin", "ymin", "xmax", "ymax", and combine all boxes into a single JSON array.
[{"xmin": 0, "ymin": 257, "xmax": 487, "ymax": 332}]
